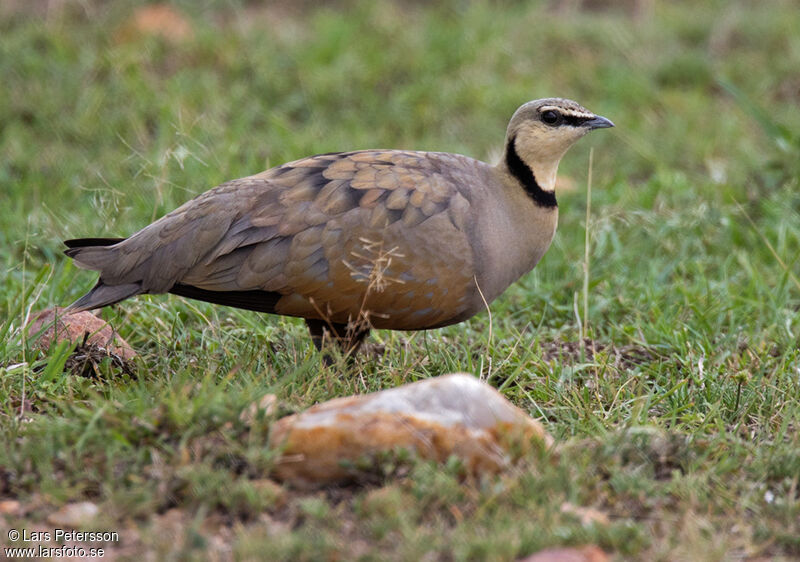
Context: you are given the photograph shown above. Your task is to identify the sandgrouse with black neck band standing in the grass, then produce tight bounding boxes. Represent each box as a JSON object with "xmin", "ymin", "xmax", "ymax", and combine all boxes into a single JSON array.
[{"xmin": 65, "ymin": 98, "xmax": 614, "ymax": 352}]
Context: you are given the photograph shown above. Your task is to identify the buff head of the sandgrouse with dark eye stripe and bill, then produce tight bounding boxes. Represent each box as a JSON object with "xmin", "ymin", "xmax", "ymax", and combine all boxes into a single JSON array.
[{"xmin": 504, "ymin": 98, "xmax": 614, "ymax": 195}]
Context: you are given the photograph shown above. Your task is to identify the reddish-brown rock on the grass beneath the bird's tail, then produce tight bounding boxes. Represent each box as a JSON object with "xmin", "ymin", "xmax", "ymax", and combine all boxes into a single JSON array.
[{"xmin": 28, "ymin": 307, "xmax": 136, "ymax": 360}]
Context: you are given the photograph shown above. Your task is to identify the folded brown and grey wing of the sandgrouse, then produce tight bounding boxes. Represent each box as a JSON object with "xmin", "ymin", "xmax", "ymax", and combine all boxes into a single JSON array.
[{"xmin": 82, "ymin": 151, "xmax": 485, "ymax": 329}]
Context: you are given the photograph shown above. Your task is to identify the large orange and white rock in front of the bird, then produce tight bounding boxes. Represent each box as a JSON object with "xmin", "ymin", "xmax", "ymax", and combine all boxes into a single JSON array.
[{"xmin": 270, "ymin": 374, "xmax": 552, "ymax": 487}]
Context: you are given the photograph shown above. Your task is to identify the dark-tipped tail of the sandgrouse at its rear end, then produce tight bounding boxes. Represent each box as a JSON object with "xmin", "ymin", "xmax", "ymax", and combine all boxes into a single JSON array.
[{"xmin": 64, "ymin": 238, "xmax": 142, "ymax": 312}]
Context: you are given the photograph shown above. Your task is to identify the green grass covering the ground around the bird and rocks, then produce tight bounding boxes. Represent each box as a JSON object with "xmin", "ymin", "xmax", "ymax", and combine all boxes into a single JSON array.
[{"xmin": 0, "ymin": 0, "xmax": 800, "ymax": 560}]
